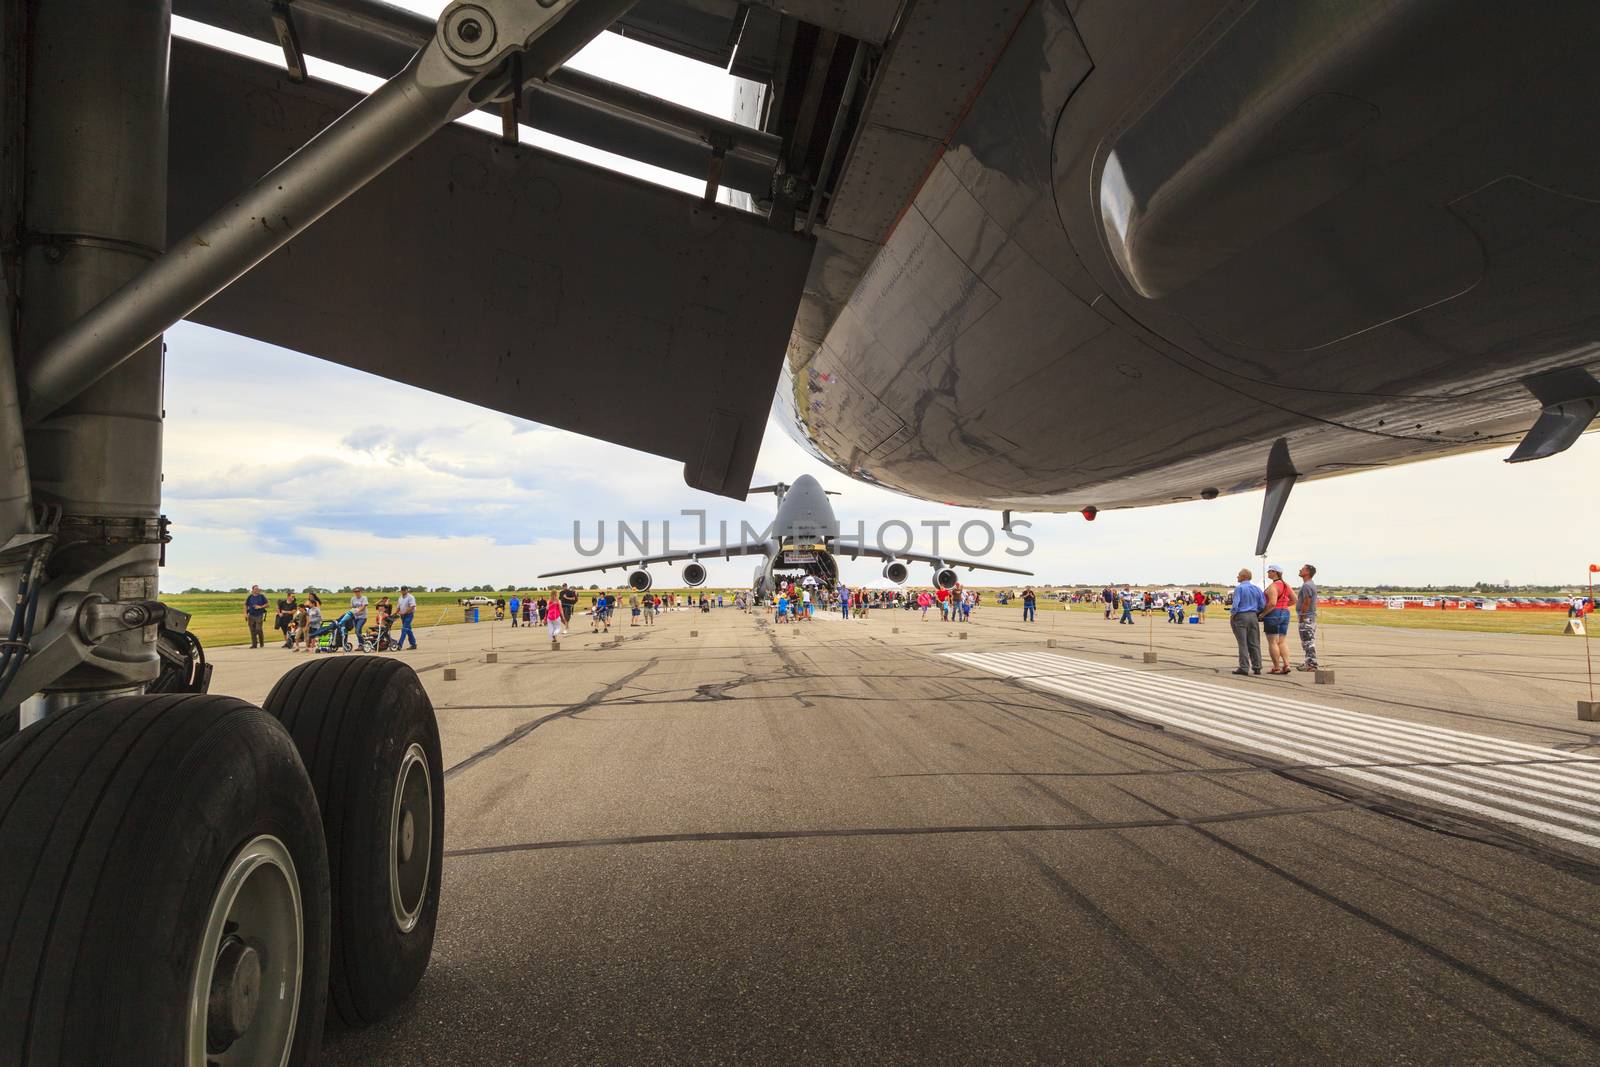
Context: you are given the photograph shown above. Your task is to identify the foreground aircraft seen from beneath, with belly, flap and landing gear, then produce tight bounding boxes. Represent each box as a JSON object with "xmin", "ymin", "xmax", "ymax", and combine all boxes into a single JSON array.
[{"xmin": 0, "ymin": 0, "xmax": 1600, "ymax": 1065}]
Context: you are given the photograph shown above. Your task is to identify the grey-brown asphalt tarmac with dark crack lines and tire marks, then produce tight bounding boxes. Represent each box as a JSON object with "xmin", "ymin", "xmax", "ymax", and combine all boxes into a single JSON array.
[{"xmin": 213, "ymin": 606, "xmax": 1600, "ymax": 1067}]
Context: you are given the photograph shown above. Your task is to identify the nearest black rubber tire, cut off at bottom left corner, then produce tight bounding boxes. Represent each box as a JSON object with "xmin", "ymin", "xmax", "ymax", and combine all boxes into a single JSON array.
[{"xmin": 0, "ymin": 694, "xmax": 330, "ymax": 1067}]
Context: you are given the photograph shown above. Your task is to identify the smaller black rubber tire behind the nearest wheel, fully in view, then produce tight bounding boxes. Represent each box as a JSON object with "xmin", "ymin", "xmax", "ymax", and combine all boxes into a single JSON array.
[{"xmin": 264, "ymin": 654, "xmax": 445, "ymax": 1027}]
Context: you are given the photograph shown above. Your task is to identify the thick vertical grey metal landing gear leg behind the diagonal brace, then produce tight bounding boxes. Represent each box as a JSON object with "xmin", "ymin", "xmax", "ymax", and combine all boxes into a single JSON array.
[{"xmin": 5, "ymin": 0, "xmax": 170, "ymax": 697}]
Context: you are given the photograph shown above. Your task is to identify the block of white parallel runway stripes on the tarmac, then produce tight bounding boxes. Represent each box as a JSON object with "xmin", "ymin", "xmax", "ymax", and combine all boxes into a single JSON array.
[{"xmin": 944, "ymin": 653, "xmax": 1600, "ymax": 848}]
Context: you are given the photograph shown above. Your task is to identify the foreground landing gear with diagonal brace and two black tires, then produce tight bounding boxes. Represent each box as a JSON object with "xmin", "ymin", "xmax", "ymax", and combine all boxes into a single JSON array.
[{"xmin": 0, "ymin": 0, "xmax": 617, "ymax": 1067}]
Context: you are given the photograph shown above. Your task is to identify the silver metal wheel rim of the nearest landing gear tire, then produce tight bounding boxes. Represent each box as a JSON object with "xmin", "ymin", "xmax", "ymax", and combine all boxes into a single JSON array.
[{"xmin": 184, "ymin": 833, "xmax": 304, "ymax": 1067}]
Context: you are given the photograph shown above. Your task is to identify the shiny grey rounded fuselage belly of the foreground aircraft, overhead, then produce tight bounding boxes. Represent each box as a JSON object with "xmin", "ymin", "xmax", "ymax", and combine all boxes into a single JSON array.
[{"xmin": 779, "ymin": 0, "xmax": 1600, "ymax": 510}]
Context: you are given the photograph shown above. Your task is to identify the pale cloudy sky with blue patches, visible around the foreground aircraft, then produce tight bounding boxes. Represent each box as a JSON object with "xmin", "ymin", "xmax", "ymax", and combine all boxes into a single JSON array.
[{"xmin": 162, "ymin": 8, "xmax": 1600, "ymax": 592}]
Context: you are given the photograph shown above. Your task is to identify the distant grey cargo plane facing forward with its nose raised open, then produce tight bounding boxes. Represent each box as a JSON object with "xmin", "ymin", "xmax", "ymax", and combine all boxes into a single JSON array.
[{"xmin": 539, "ymin": 474, "xmax": 1032, "ymax": 597}]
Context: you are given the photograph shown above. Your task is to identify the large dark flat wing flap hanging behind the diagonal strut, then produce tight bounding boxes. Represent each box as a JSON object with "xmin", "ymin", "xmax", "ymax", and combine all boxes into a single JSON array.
[{"xmin": 168, "ymin": 40, "xmax": 813, "ymax": 498}]
